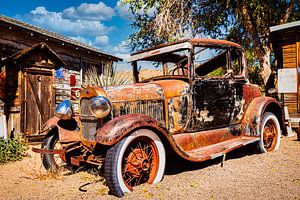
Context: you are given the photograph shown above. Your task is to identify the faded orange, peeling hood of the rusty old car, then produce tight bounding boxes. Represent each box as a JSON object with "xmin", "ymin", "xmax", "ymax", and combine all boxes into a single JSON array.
[{"xmin": 105, "ymin": 80, "xmax": 189, "ymax": 103}]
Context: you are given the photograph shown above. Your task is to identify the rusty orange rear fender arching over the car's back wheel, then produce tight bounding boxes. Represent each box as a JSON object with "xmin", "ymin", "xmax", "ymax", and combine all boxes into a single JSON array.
[{"xmin": 242, "ymin": 97, "xmax": 284, "ymax": 137}]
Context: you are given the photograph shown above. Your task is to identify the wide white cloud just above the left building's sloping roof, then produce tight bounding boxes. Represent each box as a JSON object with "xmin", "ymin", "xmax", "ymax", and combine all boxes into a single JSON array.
[{"xmin": 29, "ymin": 7, "xmax": 113, "ymax": 36}]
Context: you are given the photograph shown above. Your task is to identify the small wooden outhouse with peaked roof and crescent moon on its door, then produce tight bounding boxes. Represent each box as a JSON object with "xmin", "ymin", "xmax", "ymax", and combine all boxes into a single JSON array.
[{"xmin": 0, "ymin": 43, "xmax": 66, "ymax": 138}]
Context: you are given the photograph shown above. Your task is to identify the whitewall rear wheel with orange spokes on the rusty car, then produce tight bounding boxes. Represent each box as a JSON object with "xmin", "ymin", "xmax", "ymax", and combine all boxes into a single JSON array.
[{"xmin": 258, "ymin": 112, "xmax": 281, "ymax": 153}]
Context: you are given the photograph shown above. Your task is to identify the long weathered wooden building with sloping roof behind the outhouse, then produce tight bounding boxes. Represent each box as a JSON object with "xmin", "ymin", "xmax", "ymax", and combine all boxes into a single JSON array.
[{"xmin": 0, "ymin": 15, "xmax": 122, "ymax": 113}]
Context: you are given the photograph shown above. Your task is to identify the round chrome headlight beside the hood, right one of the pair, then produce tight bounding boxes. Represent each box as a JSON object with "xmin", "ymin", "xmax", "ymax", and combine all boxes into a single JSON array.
[{"xmin": 89, "ymin": 96, "xmax": 111, "ymax": 118}]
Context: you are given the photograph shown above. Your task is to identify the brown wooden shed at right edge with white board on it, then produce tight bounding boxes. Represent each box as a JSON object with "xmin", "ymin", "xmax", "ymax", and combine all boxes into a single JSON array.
[{"xmin": 270, "ymin": 21, "xmax": 300, "ymax": 135}]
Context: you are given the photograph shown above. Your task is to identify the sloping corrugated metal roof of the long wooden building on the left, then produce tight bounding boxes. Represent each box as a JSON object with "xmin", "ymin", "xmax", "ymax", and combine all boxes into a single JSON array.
[{"xmin": 0, "ymin": 15, "xmax": 122, "ymax": 61}]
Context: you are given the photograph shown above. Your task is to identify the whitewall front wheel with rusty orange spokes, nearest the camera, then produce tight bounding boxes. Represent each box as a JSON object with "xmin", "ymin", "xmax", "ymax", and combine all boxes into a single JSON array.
[{"xmin": 104, "ymin": 129, "xmax": 166, "ymax": 197}]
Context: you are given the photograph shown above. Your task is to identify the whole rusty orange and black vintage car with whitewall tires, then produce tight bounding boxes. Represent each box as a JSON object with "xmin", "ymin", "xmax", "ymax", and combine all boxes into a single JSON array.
[{"xmin": 34, "ymin": 39, "xmax": 283, "ymax": 197}]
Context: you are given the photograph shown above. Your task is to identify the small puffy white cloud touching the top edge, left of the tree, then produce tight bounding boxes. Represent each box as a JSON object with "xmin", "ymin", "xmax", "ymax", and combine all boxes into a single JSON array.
[{"xmin": 62, "ymin": 1, "xmax": 115, "ymax": 20}]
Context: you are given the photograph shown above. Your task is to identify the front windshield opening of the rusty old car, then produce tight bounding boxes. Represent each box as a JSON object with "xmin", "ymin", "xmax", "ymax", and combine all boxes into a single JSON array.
[{"xmin": 133, "ymin": 49, "xmax": 189, "ymax": 81}]
